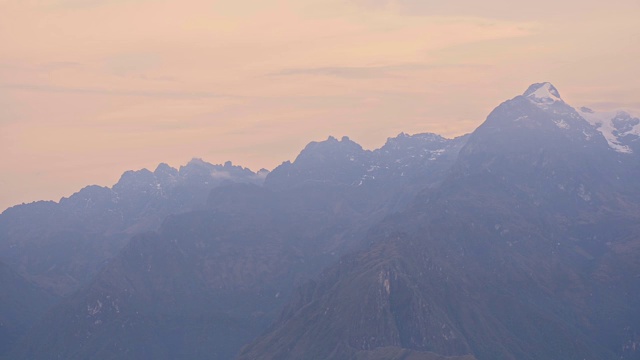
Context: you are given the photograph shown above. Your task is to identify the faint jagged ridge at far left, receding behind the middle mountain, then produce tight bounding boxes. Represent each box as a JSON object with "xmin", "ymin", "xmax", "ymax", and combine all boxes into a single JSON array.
[{"xmin": 0, "ymin": 159, "xmax": 266, "ymax": 295}]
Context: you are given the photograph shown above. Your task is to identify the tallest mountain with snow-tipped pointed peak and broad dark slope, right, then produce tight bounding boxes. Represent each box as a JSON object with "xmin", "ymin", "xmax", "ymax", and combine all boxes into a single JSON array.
[{"xmin": 239, "ymin": 83, "xmax": 640, "ymax": 360}]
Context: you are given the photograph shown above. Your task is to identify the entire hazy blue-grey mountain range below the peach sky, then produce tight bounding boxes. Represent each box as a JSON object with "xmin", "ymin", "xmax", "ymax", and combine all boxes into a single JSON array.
[{"xmin": 0, "ymin": 83, "xmax": 640, "ymax": 359}]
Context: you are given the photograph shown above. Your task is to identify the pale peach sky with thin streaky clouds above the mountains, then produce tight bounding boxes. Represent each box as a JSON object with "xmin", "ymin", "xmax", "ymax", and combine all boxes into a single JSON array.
[{"xmin": 0, "ymin": 0, "xmax": 640, "ymax": 211}]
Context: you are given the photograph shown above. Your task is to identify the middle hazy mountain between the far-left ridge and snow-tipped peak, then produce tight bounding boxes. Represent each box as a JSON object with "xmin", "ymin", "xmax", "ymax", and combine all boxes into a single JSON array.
[{"xmin": 12, "ymin": 134, "xmax": 464, "ymax": 359}]
